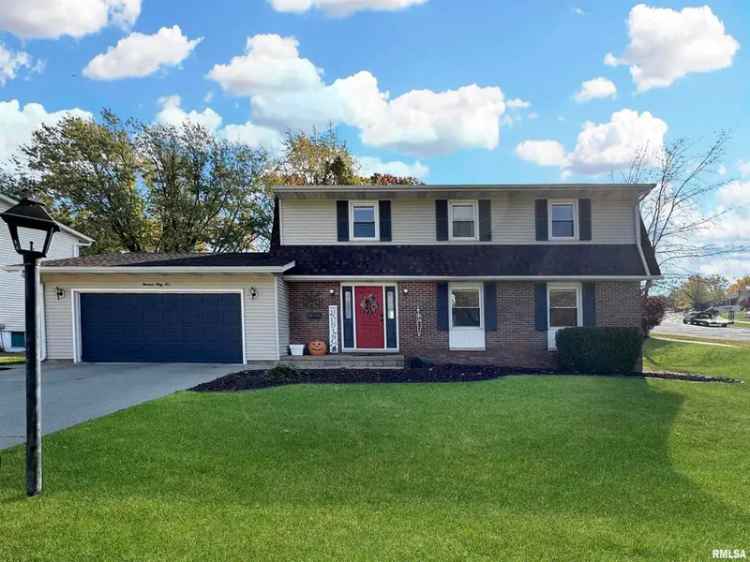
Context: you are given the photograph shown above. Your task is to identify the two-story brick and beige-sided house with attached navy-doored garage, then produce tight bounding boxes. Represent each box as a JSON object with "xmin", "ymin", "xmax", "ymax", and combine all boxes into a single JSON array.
[{"xmin": 29, "ymin": 184, "xmax": 660, "ymax": 367}]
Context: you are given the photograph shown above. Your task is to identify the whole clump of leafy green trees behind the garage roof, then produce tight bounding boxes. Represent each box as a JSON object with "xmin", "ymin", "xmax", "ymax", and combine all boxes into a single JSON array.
[{"xmin": 0, "ymin": 110, "xmax": 273, "ymax": 253}]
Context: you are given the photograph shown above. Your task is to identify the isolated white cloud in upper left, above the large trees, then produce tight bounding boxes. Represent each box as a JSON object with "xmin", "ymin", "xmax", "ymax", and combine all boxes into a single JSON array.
[{"xmin": 83, "ymin": 25, "xmax": 203, "ymax": 80}]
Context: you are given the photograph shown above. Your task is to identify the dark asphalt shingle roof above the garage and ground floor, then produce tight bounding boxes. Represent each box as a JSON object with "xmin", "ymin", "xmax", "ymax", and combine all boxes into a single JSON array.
[{"xmin": 44, "ymin": 244, "xmax": 658, "ymax": 277}]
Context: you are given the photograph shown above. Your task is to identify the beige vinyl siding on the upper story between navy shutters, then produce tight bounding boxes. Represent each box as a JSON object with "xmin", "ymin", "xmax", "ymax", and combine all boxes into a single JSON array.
[{"xmin": 280, "ymin": 191, "xmax": 635, "ymax": 245}]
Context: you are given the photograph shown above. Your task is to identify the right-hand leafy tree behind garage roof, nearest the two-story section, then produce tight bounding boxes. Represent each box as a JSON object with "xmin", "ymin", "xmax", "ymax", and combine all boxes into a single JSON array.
[{"xmin": 137, "ymin": 123, "xmax": 273, "ymax": 252}]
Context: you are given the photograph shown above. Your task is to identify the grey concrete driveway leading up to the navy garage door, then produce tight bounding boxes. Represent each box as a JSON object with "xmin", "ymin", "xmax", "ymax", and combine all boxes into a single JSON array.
[{"xmin": 0, "ymin": 363, "xmax": 242, "ymax": 449}]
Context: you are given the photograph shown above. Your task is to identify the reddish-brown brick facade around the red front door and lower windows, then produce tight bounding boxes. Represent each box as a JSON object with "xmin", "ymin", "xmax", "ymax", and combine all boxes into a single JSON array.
[{"xmin": 289, "ymin": 281, "xmax": 640, "ymax": 368}]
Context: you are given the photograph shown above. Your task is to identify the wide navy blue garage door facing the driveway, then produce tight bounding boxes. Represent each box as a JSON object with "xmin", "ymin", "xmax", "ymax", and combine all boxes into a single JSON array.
[{"xmin": 81, "ymin": 293, "xmax": 242, "ymax": 363}]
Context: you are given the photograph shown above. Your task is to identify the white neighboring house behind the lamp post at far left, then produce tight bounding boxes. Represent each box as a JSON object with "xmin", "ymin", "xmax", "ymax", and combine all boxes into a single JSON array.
[{"xmin": 0, "ymin": 193, "xmax": 94, "ymax": 351}]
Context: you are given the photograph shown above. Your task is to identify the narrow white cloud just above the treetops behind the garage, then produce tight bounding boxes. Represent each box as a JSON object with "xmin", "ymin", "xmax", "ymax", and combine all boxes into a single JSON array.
[{"xmin": 156, "ymin": 95, "xmax": 282, "ymax": 154}]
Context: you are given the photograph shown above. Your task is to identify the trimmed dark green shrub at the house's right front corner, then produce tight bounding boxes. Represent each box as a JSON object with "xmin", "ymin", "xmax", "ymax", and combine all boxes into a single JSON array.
[{"xmin": 557, "ymin": 328, "xmax": 643, "ymax": 374}]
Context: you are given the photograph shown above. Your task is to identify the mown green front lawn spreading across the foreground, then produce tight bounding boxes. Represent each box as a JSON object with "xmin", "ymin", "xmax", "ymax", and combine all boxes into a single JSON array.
[{"xmin": 0, "ymin": 341, "xmax": 750, "ymax": 561}]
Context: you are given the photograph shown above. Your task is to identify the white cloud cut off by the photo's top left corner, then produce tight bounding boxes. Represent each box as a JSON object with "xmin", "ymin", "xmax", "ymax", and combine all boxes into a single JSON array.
[{"xmin": 0, "ymin": 0, "xmax": 141, "ymax": 39}]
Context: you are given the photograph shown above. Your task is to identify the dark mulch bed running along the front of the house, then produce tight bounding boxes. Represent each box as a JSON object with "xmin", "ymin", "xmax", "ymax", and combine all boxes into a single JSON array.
[{"xmin": 190, "ymin": 365, "xmax": 742, "ymax": 392}]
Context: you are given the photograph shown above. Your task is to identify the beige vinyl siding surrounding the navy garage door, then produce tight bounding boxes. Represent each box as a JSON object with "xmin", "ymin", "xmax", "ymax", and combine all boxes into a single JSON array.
[{"xmin": 42, "ymin": 272, "xmax": 279, "ymax": 360}]
